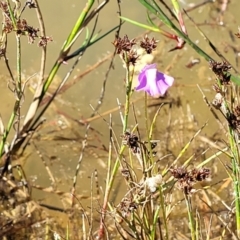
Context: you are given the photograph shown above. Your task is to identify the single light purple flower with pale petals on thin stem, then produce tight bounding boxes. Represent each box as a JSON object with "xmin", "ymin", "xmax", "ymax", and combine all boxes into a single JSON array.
[{"xmin": 135, "ymin": 64, "xmax": 174, "ymax": 97}]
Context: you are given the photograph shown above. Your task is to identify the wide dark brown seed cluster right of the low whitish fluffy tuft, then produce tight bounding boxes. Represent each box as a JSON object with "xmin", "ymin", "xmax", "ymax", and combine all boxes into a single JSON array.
[{"xmin": 170, "ymin": 167, "xmax": 211, "ymax": 195}]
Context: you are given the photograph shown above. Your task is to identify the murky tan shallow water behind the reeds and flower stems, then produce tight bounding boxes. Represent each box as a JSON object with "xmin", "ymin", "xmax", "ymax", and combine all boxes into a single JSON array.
[{"xmin": 0, "ymin": 0, "xmax": 240, "ymax": 236}]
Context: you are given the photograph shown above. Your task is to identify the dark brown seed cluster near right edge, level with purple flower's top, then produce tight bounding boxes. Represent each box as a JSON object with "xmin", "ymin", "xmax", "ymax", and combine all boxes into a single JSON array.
[{"xmin": 209, "ymin": 61, "xmax": 232, "ymax": 85}]
